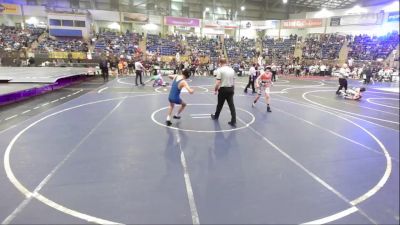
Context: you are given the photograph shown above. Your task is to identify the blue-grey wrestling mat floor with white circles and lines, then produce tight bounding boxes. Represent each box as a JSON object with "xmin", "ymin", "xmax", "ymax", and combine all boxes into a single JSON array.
[{"xmin": 0, "ymin": 74, "xmax": 399, "ymax": 224}]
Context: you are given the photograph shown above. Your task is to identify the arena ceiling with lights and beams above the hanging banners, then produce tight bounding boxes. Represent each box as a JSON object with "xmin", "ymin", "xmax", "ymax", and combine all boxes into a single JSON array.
[{"xmin": 27, "ymin": 0, "xmax": 393, "ymax": 20}]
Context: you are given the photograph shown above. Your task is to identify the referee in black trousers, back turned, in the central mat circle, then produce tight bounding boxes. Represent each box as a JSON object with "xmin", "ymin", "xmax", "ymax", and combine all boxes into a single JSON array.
[{"xmin": 211, "ymin": 58, "xmax": 236, "ymax": 127}]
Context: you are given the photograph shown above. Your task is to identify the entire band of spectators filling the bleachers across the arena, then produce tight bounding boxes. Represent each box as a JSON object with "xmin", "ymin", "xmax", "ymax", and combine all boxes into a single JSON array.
[{"xmin": 0, "ymin": 22, "xmax": 399, "ymax": 77}]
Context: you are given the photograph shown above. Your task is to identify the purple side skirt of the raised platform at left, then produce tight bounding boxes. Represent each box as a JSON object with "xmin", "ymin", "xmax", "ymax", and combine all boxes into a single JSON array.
[{"xmin": 0, "ymin": 74, "xmax": 93, "ymax": 106}]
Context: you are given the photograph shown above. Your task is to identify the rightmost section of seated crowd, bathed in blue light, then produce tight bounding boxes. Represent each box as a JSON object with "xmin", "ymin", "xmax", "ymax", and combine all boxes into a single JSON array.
[{"xmin": 348, "ymin": 32, "xmax": 399, "ymax": 60}]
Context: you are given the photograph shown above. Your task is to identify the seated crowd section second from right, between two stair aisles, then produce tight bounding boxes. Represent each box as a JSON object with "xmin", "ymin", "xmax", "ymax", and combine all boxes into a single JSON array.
[{"xmin": 303, "ymin": 34, "xmax": 346, "ymax": 60}]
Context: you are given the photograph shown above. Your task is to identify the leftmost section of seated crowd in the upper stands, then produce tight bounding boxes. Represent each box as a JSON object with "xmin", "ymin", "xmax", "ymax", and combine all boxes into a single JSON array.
[{"xmin": 0, "ymin": 25, "xmax": 45, "ymax": 51}]
